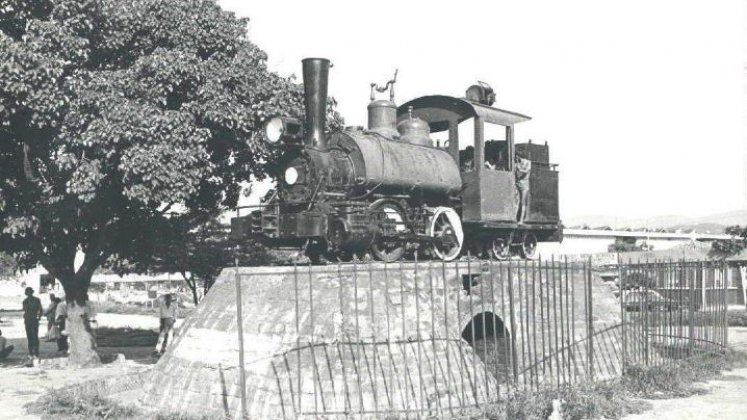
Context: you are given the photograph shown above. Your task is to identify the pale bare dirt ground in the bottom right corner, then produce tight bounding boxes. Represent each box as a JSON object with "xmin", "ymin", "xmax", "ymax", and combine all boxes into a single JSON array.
[{"xmin": 624, "ymin": 327, "xmax": 747, "ymax": 420}]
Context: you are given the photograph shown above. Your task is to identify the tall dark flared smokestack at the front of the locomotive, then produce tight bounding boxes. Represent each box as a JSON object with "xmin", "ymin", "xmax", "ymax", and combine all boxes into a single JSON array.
[{"xmin": 302, "ymin": 58, "xmax": 330, "ymax": 150}]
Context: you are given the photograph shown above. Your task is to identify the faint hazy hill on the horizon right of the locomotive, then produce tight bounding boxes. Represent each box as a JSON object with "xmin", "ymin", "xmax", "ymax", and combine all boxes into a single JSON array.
[{"xmin": 563, "ymin": 210, "xmax": 747, "ymax": 233}]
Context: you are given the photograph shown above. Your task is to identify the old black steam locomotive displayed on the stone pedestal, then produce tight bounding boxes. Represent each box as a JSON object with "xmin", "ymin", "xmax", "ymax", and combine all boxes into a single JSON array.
[{"xmin": 231, "ymin": 58, "xmax": 562, "ymax": 262}]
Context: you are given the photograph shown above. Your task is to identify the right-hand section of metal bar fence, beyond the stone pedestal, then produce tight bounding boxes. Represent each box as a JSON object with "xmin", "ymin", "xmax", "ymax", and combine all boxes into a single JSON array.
[{"xmin": 620, "ymin": 261, "xmax": 728, "ymax": 366}]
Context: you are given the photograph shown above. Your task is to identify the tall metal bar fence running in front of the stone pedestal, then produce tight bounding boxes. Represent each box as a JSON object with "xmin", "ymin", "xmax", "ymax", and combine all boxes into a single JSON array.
[{"xmin": 236, "ymin": 259, "xmax": 727, "ymax": 418}]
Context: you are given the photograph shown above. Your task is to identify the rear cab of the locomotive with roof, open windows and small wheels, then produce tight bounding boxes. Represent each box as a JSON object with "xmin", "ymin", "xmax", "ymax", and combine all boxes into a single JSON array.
[{"xmin": 398, "ymin": 95, "xmax": 562, "ymax": 257}]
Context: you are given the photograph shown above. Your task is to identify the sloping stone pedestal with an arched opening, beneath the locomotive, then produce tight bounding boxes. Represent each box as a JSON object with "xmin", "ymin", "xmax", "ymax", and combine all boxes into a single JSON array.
[{"xmin": 141, "ymin": 262, "xmax": 619, "ymax": 419}]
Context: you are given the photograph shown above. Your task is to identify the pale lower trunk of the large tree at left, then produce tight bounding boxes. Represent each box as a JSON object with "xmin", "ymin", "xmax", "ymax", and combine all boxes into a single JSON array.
[{"xmin": 60, "ymin": 276, "xmax": 101, "ymax": 367}]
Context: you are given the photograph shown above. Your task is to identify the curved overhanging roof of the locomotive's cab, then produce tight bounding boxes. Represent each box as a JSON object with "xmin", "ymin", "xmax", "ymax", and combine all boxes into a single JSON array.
[{"xmin": 397, "ymin": 95, "xmax": 531, "ymax": 133}]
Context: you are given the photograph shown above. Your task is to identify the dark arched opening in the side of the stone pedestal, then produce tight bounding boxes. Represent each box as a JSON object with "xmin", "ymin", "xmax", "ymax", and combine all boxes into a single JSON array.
[{"xmin": 462, "ymin": 312, "xmax": 516, "ymax": 382}]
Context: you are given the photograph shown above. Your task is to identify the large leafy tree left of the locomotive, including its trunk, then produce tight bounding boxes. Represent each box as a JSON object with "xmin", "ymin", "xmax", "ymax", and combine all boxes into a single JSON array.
[{"xmin": 0, "ymin": 0, "xmax": 302, "ymax": 364}]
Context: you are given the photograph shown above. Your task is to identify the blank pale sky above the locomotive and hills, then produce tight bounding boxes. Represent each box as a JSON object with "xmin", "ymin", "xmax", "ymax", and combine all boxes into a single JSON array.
[{"xmin": 219, "ymin": 0, "xmax": 747, "ymax": 221}]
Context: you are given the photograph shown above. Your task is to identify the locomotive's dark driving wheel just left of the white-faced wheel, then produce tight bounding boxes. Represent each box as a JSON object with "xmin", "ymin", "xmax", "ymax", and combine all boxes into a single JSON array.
[{"xmin": 369, "ymin": 200, "xmax": 407, "ymax": 263}]
